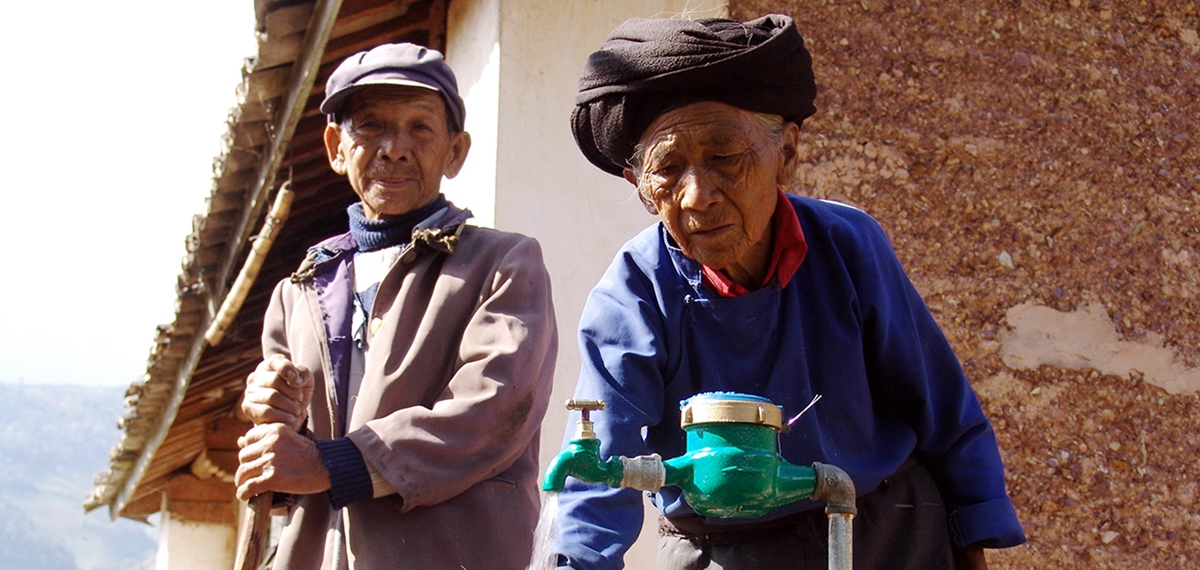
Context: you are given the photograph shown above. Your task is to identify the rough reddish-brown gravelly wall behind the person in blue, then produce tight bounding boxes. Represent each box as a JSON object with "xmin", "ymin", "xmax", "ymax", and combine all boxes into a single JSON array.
[{"xmin": 730, "ymin": 0, "xmax": 1200, "ymax": 569}]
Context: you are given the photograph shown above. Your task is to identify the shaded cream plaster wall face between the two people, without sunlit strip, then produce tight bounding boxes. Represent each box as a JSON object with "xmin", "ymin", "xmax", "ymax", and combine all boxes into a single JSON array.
[{"xmin": 496, "ymin": 0, "xmax": 724, "ymax": 456}]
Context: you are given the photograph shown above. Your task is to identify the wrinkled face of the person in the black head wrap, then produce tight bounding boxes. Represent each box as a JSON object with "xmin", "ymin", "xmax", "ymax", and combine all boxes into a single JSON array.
[{"xmin": 625, "ymin": 102, "xmax": 799, "ymax": 286}]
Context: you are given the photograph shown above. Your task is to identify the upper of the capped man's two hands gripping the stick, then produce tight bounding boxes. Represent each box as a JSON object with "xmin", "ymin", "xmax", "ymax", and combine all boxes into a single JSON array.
[{"xmin": 241, "ymin": 354, "xmax": 316, "ymax": 431}]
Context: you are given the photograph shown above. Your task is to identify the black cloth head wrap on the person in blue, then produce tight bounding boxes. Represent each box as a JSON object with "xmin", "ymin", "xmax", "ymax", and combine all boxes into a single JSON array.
[{"xmin": 571, "ymin": 14, "xmax": 816, "ymax": 176}]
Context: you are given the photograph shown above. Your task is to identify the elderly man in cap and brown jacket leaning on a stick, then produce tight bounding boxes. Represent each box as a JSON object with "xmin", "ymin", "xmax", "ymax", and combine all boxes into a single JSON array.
[{"xmin": 236, "ymin": 44, "xmax": 557, "ymax": 570}]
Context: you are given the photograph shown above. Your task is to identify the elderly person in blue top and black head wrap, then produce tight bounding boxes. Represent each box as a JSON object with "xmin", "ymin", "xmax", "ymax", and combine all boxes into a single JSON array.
[{"xmin": 556, "ymin": 16, "xmax": 1025, "ymax": 570}]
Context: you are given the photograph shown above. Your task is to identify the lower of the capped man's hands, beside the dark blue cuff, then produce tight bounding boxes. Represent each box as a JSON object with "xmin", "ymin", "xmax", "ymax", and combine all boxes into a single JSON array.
[{"xmin": 235, "ymin": 424, "xmax": 329, "ymax": 500}]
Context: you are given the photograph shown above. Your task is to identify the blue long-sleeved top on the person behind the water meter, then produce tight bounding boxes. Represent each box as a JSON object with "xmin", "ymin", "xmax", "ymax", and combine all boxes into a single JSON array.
[{"xmin": 558, "ymin": 196, "xmax": 1025, "ymax": 569}]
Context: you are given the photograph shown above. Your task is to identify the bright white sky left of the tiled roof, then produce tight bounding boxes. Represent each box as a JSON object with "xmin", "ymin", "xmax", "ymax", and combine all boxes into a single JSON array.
[{"xmin": 0, "ymin": 0, "xmax": 256, "ymax": 385}]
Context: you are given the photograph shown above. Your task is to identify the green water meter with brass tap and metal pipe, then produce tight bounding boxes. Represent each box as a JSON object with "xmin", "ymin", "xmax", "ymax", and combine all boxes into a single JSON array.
[{"xmin": 541, "ymin": 392, "xmax": 856, "ymax": 570}]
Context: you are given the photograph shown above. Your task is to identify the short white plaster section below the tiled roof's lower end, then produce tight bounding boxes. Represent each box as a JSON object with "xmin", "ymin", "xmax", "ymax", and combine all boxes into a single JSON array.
[{"xmin": 155, "ymin": 509, "xmax": 238, "ymax": 570}]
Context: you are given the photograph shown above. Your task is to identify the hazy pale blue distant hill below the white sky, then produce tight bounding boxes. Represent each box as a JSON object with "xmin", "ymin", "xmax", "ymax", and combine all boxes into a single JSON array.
[{"xmin": 0, "ymin": 384, "xmax": 157, "ymax": 570}]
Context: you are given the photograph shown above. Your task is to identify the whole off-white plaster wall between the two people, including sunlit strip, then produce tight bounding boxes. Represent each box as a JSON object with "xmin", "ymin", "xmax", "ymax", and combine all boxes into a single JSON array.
[{"xmin": 446, "ymin": 0, "xmax": 726, "ymax": 570}]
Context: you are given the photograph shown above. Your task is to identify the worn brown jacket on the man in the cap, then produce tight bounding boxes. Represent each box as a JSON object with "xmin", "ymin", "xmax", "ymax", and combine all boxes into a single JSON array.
[{"xmin": 263, "ymin": 211, "xmax": 558, "ymax": 570}]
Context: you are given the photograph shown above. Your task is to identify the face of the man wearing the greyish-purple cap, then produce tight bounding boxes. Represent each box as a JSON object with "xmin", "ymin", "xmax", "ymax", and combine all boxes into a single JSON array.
[{"xmin": 325, "ymin": 86, "xmax": 470, "ymax": 220}]
